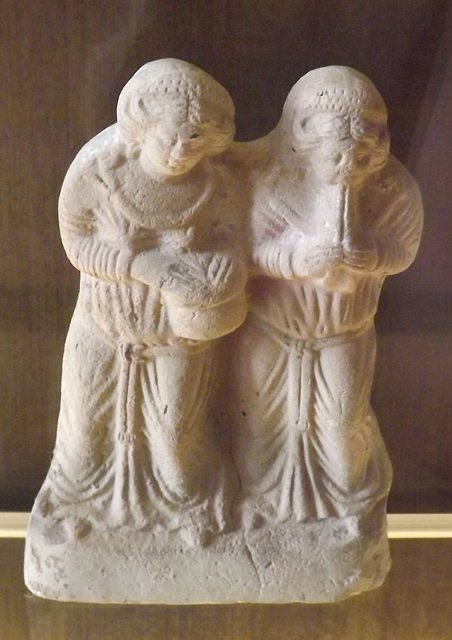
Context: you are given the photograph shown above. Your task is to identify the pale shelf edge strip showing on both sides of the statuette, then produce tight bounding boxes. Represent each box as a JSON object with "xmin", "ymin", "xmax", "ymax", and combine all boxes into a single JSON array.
[{"xmin": 0, "ymin": 512, "xmax": 452, "ymax": 539}]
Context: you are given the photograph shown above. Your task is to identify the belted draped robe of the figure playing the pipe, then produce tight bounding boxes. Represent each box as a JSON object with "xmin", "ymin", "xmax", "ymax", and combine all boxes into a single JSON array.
[{"xmin": 234, "ymin": 158, "xmax": 422, "ymax": 521}]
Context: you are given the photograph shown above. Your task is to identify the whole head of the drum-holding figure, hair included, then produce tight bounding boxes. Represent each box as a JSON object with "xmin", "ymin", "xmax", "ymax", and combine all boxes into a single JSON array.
[{"xmin": 117, "ymin": 58, "xmax": 235, "ymax": 176}]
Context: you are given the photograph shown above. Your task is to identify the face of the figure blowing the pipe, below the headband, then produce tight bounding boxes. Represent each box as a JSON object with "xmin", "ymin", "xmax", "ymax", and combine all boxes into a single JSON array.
[{"xmin": 294, "ymin": 113, "xmax": 389, "ymax": 185}]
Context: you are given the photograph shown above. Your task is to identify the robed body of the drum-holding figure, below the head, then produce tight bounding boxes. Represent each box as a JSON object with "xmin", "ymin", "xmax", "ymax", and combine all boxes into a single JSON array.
[{"xmin": 37, "ymin": 125, "xmax": 246, "ymax": 531}]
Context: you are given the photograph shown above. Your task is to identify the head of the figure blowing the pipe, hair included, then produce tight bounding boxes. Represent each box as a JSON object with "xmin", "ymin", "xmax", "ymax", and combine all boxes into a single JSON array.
[{"xmin": 280, "ymin": 66, "xmax": 389, "ymax": 184}]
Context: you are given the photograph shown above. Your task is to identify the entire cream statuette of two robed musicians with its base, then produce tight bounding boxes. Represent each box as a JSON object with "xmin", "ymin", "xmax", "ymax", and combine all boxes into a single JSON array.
[{"xmin": 25, "ymin": 60, "xmax": 422, "ymax": 604}]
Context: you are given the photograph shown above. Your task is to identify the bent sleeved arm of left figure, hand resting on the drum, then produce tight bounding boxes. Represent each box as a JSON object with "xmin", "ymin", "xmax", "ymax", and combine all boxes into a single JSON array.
[{"xmin": 59, "ymin": 151, "xmax": 246, "ymax": 306}]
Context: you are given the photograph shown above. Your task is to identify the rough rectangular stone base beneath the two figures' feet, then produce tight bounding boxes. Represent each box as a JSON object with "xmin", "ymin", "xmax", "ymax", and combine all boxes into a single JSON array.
[{"xmin": 25, "ymin": 515, "xmax": 390, "ymax": 604}]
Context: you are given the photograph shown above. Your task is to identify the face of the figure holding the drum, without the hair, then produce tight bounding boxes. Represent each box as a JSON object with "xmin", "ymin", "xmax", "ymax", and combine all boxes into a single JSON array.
[{"xmin": 141, "ymin": 115, "xmax": 230, "ymax": 176}]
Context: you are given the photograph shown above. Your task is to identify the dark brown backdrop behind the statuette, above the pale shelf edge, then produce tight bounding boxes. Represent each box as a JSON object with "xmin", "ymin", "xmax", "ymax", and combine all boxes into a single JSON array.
[{"xmin": 0, "ymin": 0, "xmax": 452, "ymax": 511}]
